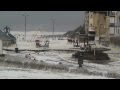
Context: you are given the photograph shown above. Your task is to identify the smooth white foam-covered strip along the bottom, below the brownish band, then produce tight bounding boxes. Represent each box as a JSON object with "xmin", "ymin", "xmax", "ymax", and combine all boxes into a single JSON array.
[{"xmin": 0, "ymin": 67, "xmax": 107, "ymax": 79}]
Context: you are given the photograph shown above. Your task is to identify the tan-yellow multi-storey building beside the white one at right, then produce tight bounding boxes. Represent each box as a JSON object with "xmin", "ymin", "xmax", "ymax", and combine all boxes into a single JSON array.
[{"xmin": 85, "ymin": 11, "xmax": 107, "ymax": 41}]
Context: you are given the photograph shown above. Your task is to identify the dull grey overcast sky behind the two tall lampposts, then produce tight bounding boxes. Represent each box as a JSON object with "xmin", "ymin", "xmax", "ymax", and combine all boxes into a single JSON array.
[{"xmin": 0, "ymin": 11, "xmax": 84, "ymax": 32}]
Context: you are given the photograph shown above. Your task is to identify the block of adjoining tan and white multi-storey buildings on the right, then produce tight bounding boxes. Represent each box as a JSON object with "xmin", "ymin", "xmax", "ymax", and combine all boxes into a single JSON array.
[{"xmin": 85, "ymin": 11, "xmax": 120, "ymax": 47}]
